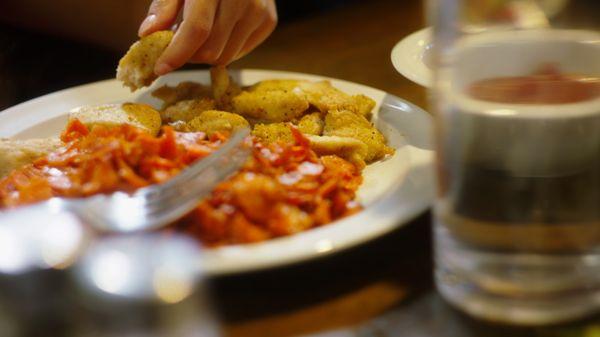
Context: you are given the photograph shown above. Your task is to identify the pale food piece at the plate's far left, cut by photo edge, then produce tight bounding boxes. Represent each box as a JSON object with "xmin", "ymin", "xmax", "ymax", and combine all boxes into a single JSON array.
[{"xmin": 0, "ymin": 138, "xmax": 63, "ymax": 178}]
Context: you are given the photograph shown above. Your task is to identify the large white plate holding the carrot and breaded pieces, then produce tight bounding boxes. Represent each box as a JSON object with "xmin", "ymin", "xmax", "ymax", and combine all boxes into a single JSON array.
[{"xmin": 0, "ymin": 70, "xmax": 433, "ymax": 275}]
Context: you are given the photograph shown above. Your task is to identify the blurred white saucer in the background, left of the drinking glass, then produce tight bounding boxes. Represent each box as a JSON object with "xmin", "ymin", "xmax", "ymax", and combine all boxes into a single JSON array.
[{"xmin": 391, "ymin": 27, "xmax": 432, "ymax": 87}]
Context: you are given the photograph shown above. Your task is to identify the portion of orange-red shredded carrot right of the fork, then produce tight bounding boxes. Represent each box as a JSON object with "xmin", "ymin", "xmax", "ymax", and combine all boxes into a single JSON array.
[{"xmin": 178, "ymin": 128, "xmax": 362, "ymax": 246}]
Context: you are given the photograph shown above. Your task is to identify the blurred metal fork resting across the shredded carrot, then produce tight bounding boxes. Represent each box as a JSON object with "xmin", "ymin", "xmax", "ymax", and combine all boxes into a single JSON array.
[{"xmin": 0, "ymin": 129, "xmax": 250, "ymax": 232}]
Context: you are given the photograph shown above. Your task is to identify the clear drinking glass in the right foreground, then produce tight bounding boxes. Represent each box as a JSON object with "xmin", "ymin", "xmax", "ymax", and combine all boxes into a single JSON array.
[{"xmin": 428, "ymin": 0, "xmax": 600, "ymax": 325}]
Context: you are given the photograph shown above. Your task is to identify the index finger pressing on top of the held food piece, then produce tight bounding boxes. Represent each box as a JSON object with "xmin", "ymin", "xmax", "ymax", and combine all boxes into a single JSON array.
[{"xmin": 154, "ymin": 0, "xmax": 218, "ymax": 76}]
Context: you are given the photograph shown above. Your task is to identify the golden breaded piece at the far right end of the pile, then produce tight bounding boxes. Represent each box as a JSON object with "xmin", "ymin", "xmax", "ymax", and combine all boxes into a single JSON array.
[{"xmin": 323, "ymin": 110, "xmax": 394, "ymax": 163}]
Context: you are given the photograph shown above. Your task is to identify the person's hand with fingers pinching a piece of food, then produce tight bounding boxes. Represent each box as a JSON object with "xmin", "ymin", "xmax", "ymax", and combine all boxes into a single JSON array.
[{"xmin": 139, "ymin": 0, "xmax": 277, "ymax": 75}]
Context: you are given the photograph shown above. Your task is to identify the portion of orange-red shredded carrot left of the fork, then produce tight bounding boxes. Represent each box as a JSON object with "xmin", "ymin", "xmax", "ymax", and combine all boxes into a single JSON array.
[{"xmin": 0, "ymin": 119, "xmax": 224, "ymax": 207}]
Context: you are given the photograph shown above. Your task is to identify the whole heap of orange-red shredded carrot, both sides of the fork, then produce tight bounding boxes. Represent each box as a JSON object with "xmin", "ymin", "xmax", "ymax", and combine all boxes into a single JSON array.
[{"xmin": 0, "ymin": 120, "xmax": 362, "ymax": 246}]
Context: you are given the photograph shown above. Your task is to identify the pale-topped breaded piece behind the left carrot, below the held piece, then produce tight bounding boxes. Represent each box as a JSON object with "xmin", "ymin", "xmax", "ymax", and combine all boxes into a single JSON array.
[{"xmin": 69, "ymin": 103, "xmax": 161, "ymax": 135}]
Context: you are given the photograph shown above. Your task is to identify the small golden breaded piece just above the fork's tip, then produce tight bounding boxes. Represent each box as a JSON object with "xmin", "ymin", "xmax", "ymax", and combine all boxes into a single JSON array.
[{"xmin": 188, "ymin": 110, "xmax": 249, "ymax": 136}]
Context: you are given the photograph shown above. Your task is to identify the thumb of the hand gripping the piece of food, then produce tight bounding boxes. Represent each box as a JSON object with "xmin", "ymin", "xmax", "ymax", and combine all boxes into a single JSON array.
[{"xmin": 138, "ymin": 0, "xmax": 183, "ymax": 37}]
